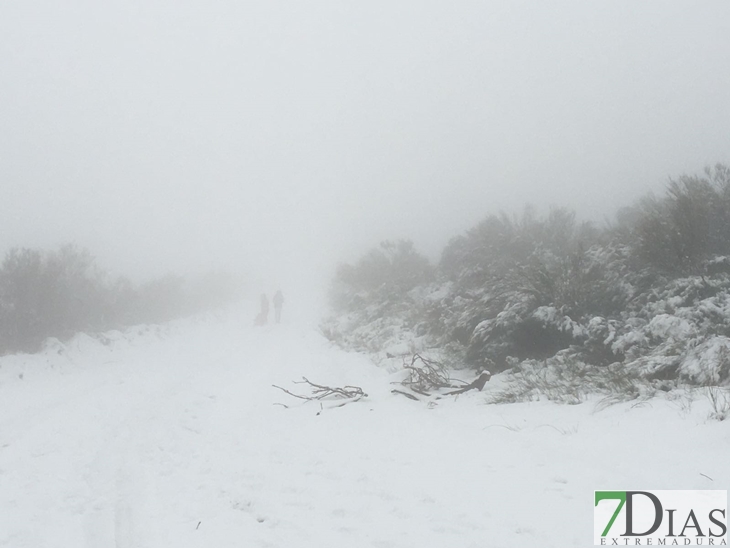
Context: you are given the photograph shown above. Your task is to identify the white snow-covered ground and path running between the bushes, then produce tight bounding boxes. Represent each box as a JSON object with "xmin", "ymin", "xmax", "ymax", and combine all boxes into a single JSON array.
[{"xmin": 0, "ymin": 310, "xmax": 730, "ymax": 548}]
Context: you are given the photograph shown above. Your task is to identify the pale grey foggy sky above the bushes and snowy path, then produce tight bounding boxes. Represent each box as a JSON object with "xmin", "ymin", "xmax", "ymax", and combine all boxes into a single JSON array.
[{"xmin": 0, "ymin": 0, "xmax": 730, "ymax": 289}]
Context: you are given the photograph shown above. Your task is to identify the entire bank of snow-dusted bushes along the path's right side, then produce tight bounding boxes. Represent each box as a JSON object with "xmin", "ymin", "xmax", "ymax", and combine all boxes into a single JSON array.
[{"xmin": 328, "ymin": 166, "xmax": 730, "ymax": 388}]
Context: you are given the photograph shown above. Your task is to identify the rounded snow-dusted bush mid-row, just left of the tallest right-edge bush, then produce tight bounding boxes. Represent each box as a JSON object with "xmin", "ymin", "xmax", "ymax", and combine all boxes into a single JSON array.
[{"xmin": 432, "ymin": 209, "xmax": 636, "ymax": 371}]
